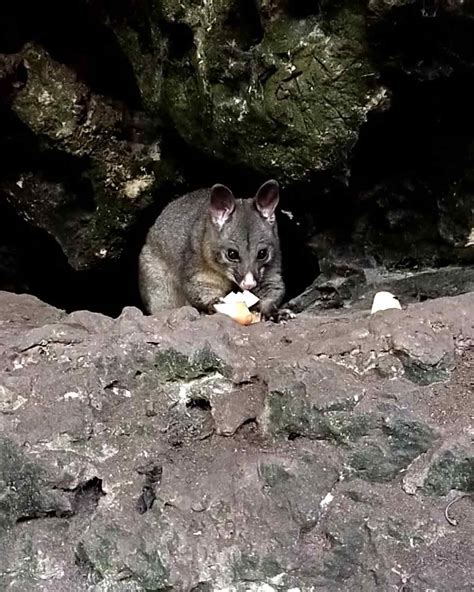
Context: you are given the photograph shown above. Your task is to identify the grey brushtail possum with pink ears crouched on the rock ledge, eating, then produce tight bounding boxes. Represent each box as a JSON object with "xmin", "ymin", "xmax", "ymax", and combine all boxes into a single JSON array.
[{"xmin": 139, "ymin": 180, "xmax": 285, "ymax": 317}]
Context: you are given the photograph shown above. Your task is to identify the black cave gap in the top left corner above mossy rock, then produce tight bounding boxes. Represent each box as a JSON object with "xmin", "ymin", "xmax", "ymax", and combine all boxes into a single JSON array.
[{"xmin": 0, "ymin": 0, "xmax": 144, "ymax": 109}]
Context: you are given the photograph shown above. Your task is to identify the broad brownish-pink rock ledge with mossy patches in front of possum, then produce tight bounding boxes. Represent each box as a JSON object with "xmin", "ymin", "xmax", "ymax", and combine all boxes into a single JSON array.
[{"xmin": 0, "ymin": 292, "xmax": 474, "ymax": 592}]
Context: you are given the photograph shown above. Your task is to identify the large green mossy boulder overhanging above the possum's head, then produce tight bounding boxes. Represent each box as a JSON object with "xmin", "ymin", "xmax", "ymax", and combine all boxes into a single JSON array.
[{"xmin": 161, "ymin": 0, "xmax": 387, "ymax": 181}]
